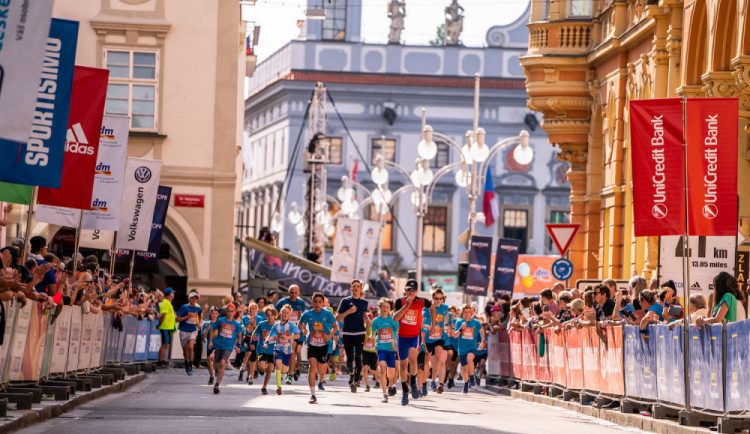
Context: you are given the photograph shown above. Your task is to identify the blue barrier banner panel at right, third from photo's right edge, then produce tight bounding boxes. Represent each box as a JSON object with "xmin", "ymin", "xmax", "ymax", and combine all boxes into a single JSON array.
[{"xmin": 654, "ymin": 324, "xmax": 685, "ymax": 405}]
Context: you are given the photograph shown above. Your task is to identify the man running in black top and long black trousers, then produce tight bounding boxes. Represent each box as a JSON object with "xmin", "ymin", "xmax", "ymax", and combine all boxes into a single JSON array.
[{"xmin": 336, "ymin": 279, "xmax": 367, "ymax": 393}]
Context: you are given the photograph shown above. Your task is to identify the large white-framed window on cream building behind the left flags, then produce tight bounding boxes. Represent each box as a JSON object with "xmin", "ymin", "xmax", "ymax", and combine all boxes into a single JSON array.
[{"xmin": 104, "ymin": 50, "xmax": 159, "ymax": 131}]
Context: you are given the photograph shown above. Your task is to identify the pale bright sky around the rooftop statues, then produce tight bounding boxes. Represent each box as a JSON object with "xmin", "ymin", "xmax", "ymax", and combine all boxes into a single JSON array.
[{"xmin": 243, "ymin": 0, "xmax": 529, "ymax": 62}]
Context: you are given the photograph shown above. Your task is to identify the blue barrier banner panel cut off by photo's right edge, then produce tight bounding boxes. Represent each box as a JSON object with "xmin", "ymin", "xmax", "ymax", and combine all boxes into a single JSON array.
[{"xmin": 724, "ymin": 320, "xmax": 750, "ymax": 411}]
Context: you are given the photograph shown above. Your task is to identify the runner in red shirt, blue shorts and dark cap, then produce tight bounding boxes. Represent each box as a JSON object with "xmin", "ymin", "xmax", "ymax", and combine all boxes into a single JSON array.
[{"xmin": 393, "ymin": 279, "xmax": 435, "ymax": 405}]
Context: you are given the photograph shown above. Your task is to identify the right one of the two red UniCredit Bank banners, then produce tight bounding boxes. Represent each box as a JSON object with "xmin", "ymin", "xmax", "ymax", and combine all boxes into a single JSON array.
[{"xmin": 685, "ymin": 98, "xmax": 739, "ymax": 236}]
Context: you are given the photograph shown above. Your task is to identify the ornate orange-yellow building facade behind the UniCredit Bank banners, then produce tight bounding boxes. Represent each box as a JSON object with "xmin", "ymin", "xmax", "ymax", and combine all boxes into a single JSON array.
[{"xmin": 521, "ymin": 0, "xmax": 750, "ymax": 279}]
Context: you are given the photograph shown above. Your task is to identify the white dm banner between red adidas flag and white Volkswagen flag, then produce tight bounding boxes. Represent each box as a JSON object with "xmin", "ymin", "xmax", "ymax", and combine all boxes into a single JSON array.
[{"xmin": 81, "ymin": 115, "xmax": 130, "ymax": 231}]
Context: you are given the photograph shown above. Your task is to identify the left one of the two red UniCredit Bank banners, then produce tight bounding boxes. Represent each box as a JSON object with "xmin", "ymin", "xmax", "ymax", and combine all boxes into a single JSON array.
[{"xmin": 630, "ymin": 98, "xmax": 684, "ymax": 237}]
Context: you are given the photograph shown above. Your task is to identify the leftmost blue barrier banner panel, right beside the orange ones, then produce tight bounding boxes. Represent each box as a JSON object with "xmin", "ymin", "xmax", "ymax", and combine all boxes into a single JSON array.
[{"xmin": 623, "ymin": 325, "xmax": 657, "ymax": 399}]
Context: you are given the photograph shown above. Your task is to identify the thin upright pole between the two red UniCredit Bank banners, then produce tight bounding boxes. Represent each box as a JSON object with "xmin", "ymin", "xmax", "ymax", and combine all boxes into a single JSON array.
[{"xmin": 682, "ymin": 96, "xmax": 690, "ymax": 413}]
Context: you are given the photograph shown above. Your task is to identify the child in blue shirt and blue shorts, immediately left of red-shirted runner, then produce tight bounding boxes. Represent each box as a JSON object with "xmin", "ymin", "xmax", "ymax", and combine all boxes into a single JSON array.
[{"xmin": 370, "ymin": 297, "xmax": 398, "ymax": 402}]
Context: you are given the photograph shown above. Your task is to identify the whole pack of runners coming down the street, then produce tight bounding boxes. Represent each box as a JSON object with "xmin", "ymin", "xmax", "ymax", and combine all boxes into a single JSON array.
[{"xmin": 187, "ymin": 280, "xmax": 488, "ymax": 405}]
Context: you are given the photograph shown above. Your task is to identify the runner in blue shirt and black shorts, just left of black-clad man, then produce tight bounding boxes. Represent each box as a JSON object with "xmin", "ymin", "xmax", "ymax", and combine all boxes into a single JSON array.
[{"xmin": 299, "ymin": 292, "xmax": 339, "ymax": 404}]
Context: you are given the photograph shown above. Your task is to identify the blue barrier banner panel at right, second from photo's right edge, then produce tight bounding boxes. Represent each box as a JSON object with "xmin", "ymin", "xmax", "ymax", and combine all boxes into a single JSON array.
[{"xmin": 689, "ymin": 324, "xmax": 724, "ymax": 411}]
